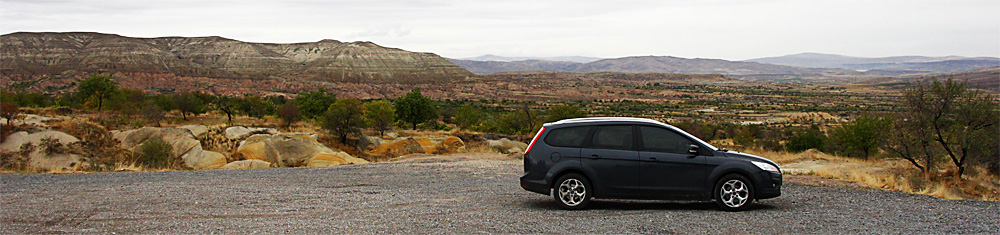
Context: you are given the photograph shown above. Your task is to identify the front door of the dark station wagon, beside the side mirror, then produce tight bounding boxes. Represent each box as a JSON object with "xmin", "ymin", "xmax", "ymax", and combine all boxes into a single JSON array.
[{"xmin": 637, "ymin": 126, "xmax": 708, "ymax": 198}]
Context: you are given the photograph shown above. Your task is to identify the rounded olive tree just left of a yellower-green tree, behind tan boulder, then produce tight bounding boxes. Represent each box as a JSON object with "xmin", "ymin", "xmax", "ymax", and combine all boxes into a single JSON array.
[{"xmin": 321, "ymin": 98, "xmax": 365, "ymax": 144}]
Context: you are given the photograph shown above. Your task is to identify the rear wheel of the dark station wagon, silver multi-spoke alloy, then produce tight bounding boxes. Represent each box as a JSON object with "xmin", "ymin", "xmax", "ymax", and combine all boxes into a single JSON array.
[{"xmin": 552, "ymin": 173, "xmax": 594, "ymax": 210}]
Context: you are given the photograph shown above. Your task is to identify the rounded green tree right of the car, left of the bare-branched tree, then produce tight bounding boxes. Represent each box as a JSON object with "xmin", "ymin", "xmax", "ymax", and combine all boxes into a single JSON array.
[{"xmin": 834, "ymin": 116, "xmax": 888, "ymax": 160}]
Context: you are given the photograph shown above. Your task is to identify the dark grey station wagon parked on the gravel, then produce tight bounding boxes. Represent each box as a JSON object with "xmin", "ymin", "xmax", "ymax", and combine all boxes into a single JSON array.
[{"xmin": 520, "ymin": 117, "xmax": 782, "ymax": 211}]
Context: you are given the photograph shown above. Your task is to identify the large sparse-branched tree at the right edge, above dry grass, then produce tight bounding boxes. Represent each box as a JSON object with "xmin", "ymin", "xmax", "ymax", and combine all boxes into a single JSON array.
[{"xmin": 897, "ymin": 78, "xmax": 1000, "ymax": 177}]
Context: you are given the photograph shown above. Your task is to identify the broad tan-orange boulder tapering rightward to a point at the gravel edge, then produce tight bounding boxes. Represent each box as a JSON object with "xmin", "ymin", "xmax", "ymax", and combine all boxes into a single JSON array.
[{"xmin": 236, "ymin": 133, "xmax": 368, "ymax": 167}]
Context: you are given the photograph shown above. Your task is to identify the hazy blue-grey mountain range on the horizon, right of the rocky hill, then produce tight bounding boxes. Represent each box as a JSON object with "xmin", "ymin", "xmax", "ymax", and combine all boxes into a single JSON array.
[{"xmin": 448, "ymin": 53, "xmax": 1000, "ymax": 76}]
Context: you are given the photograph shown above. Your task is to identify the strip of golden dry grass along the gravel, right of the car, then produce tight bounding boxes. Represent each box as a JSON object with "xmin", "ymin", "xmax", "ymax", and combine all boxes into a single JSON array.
[{"xmin": 751, "ymin": 150, "xmax": 1000, "ymax": 201}]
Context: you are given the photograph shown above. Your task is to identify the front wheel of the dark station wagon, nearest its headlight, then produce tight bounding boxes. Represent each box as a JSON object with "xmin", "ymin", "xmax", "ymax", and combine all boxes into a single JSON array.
[{"xmin": 713, "ymin": 174, "xmax": 754, "ymax": 211}]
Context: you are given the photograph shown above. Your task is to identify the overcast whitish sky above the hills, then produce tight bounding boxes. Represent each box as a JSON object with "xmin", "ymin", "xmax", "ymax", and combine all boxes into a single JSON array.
[{"xmin": 0, "ymin": 0, "xmax": 1000, "ymax": 60}]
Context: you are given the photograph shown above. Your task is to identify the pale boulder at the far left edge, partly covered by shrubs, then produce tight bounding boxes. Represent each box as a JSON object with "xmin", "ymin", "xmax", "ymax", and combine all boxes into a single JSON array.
[{"xmin": 0, "ymin": 131, "xmax": 83, "ymax": 171}]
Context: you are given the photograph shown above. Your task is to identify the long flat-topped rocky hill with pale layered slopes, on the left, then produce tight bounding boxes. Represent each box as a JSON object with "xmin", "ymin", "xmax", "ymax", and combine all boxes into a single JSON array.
[{"xmin": 0, "ymin": 32, "xmax": 472, "ymax": 83}]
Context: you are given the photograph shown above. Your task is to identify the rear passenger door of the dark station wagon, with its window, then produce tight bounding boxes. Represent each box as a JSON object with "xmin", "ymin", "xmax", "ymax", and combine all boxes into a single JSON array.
[{"xmin": 580, "ymin": 125, "xmax": 640, "ymax": 197}]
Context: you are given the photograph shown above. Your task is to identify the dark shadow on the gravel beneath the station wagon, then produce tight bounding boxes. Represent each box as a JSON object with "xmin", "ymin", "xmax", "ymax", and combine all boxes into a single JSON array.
[{"xmin": 525, "ymin": 199, "xmax": 778, "ymax": 211}]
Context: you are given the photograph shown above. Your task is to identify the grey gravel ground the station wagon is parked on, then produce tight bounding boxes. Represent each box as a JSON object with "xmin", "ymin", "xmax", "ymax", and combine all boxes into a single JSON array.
[{"xmin": 0, "ymin": 155, "xmax": 1000, "ymax": 234}]
